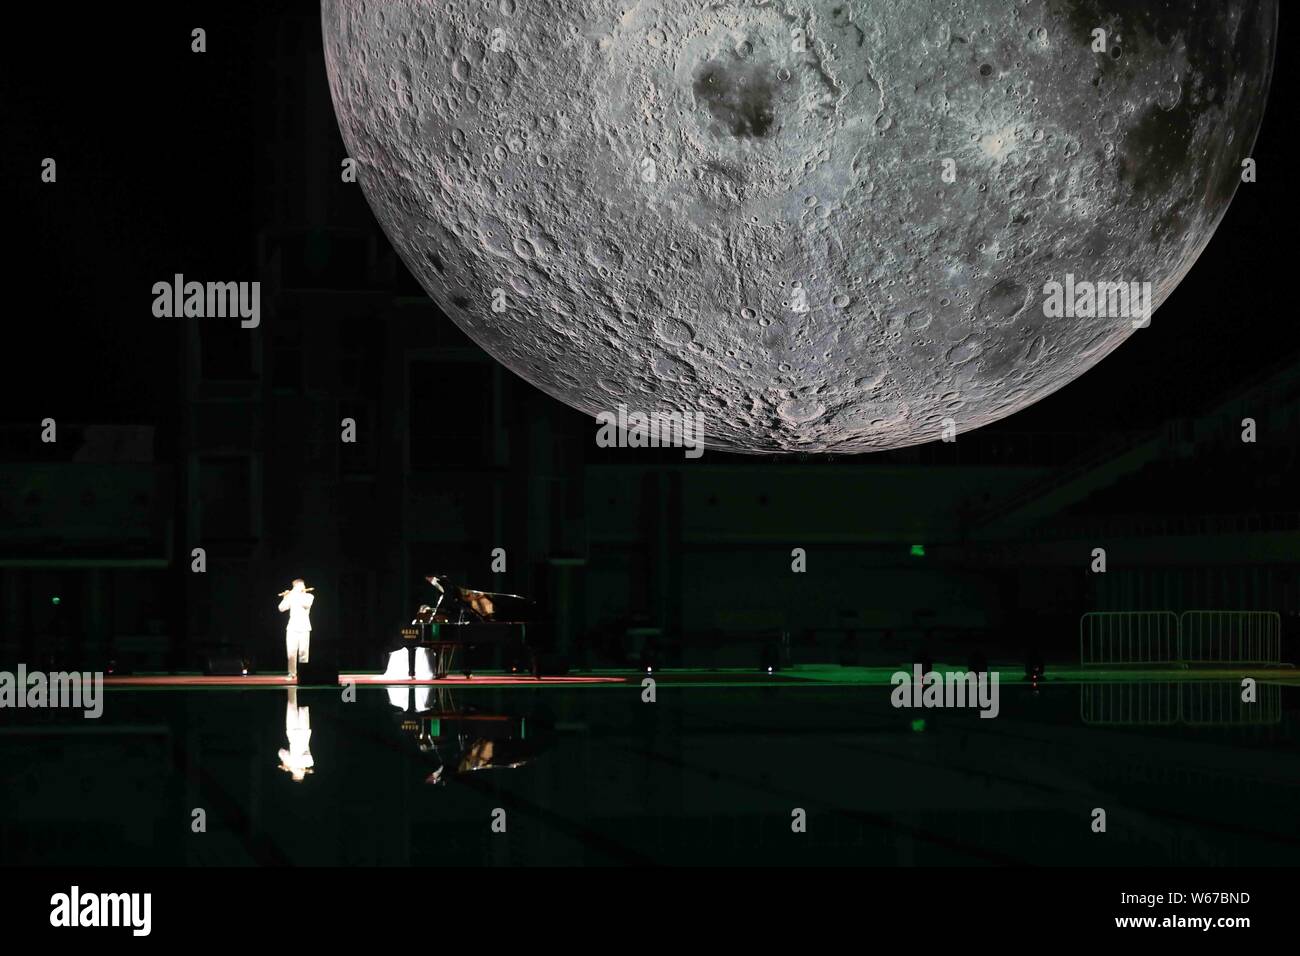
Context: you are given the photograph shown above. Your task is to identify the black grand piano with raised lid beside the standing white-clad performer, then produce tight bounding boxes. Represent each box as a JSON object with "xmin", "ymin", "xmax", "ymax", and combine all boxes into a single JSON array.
[{"xmin": 384, "ymin": 574, "xmax": 537, "ymax": 680}]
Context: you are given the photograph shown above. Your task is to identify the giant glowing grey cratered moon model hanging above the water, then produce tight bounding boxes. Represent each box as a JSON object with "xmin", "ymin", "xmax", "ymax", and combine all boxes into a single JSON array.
[{"xmin": 321, "ymin": 0, "xmax": 1277, "ymax": 453}]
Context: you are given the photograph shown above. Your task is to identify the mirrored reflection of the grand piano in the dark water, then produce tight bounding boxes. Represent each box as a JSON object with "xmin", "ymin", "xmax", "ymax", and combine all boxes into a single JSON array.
[{"xmin": 389, "ymin": 687, "xmax": 538, "ymax": 783}]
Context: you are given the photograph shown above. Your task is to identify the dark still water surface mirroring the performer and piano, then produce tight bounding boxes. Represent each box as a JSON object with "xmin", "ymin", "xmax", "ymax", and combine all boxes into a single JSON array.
[{"xmin": 0, "ymin": 680, "xmax": 1300, "ymax": 865}]
